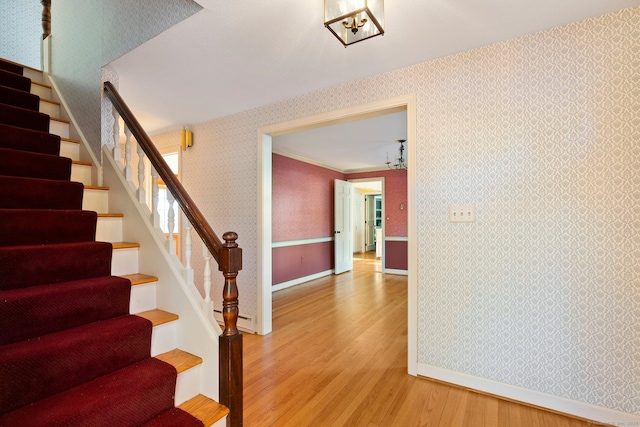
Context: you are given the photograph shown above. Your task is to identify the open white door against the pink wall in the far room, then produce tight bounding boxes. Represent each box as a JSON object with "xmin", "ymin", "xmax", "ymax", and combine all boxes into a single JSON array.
[{"xmin": 333, "ymin": 179, "xmax": 353, "ymax": 274}]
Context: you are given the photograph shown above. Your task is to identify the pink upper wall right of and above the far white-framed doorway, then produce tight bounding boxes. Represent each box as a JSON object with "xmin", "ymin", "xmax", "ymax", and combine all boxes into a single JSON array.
[{"xmin": 345, "ymin": 170, "xmax": 407, "ymax": 237}]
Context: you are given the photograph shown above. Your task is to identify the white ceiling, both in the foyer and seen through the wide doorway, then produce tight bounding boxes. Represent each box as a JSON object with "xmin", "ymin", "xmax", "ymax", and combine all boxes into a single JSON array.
[{"xmin": 109, "ymin": 0, "xmax": 640, "ymax": 170}]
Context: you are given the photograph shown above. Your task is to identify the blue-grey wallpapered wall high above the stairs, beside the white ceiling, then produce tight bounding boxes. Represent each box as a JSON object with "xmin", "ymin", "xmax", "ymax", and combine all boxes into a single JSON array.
[{"xmin": 50, "ymin": 0, "xmax": 201, "ymax": 159}]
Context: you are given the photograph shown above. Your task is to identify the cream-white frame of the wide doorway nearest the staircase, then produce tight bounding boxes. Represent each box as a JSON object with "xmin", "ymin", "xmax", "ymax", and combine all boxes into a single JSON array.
[{"xmin": 256, "ymin": 94, "xmax": 418, "ymax": 375}]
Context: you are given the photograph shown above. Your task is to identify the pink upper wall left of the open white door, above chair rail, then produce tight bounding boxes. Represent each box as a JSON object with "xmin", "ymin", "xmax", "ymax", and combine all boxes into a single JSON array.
[{"xmin": 272, "ymin": 154, "xmax": 345, "ymax": 242}]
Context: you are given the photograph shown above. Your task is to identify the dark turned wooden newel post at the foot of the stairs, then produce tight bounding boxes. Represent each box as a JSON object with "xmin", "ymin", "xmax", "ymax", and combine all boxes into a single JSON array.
[{"xmin": 218, "ymin": 232, "xmax": 243, "ymax": 427}]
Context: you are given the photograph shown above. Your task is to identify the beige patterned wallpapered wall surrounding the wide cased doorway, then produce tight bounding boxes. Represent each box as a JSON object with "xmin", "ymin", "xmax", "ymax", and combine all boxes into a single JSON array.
[{"xmin": 165, "ymin": 8, "xmax": 640, "ymax": 414}]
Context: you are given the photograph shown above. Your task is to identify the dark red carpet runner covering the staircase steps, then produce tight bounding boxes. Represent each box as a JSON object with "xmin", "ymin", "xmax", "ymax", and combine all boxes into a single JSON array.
[{"xmin": 0, "ymin": 61, "xmax": 202, "ymax": 427}]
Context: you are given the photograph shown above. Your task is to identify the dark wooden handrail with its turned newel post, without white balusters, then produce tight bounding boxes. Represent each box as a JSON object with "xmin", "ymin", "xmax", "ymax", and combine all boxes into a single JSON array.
[{"xmin": 104, "ymin": 82, "xmax": 243, "ymax": 427}]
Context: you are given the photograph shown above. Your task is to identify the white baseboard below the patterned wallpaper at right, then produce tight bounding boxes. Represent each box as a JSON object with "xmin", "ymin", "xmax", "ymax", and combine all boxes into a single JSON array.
[{"xmin": 418, "ymin": 363, "xmax": 640, "ymax": 426}]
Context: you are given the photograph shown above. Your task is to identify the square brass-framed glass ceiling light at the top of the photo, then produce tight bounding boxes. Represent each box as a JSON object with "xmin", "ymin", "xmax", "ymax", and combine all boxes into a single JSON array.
[{"xmin": 324, "ymin": 0, "xmax": 384, "ymax": 47}]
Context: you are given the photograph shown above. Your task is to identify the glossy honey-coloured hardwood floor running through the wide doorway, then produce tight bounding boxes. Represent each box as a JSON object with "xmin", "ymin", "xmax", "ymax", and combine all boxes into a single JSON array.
[{"xmin": 244, "ymin": 266, "xmax": 588, "ymax": 427}]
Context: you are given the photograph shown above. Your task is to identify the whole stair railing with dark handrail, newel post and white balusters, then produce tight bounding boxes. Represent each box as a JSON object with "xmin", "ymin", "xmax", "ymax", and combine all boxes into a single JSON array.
[{"xmin": 104, "ymin": 82, "xmax": 243, "ymax": 426}]
